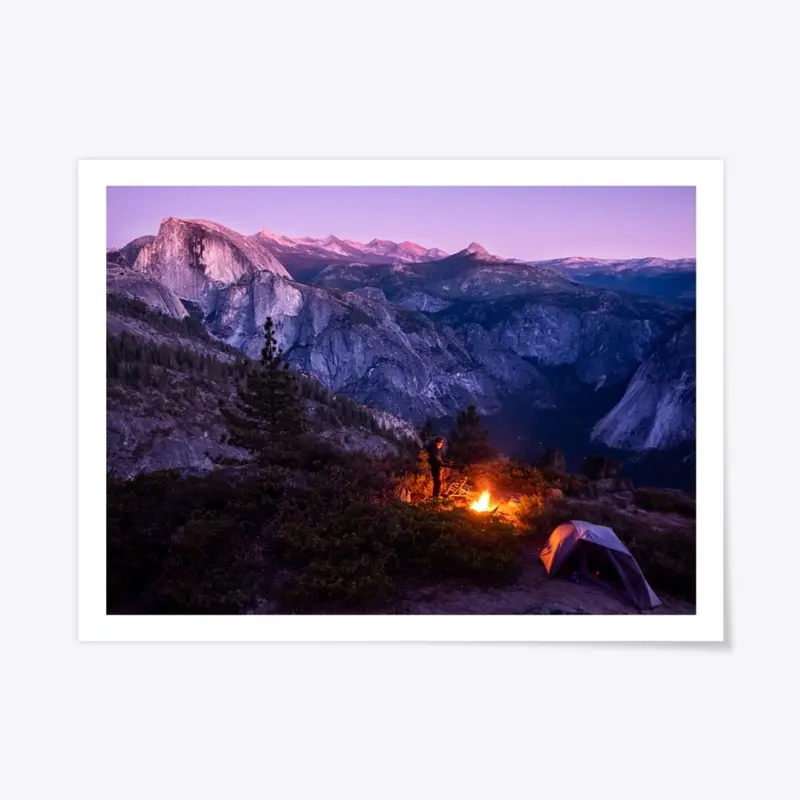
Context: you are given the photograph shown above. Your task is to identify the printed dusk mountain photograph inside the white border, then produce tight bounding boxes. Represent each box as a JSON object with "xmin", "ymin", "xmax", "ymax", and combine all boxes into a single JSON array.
[{"xmin": 81, "ymin": 161, "xmax": 721, "ymax": 638}]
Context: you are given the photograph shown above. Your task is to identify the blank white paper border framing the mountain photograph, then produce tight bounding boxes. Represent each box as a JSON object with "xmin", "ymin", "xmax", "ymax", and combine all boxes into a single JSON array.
[{"xmin": 78, "ymin": 159, "xmax": 724, "ymax": 642}]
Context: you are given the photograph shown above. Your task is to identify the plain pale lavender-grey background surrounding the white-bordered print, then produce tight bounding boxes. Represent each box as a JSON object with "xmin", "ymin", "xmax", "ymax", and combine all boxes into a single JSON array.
[{"xmin": 0, "ymin": 0, "xmax": 800, "ymax": 800}]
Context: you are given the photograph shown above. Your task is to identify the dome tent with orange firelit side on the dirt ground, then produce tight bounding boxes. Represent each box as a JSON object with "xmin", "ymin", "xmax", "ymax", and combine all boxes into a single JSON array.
[{"xmin": 539, "ymin": 519, "xmax": 661, "ymax": 609}]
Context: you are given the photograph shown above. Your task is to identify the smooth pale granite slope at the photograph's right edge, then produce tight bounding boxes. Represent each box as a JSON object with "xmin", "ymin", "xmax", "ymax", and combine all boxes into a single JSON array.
[{"xmin": 592, "ymin": 321, "xmax": 696, "ymax": 450}]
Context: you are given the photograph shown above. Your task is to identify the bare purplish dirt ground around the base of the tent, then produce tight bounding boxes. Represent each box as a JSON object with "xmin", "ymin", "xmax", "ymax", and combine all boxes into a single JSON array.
[{"xmin": 395, "ymin": 543, "xmax": 695, "ymax": 614}]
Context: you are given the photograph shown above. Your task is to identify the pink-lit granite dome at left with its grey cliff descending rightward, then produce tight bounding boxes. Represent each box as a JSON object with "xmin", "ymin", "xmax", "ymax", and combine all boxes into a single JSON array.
[{"xmin": 125, "ymin": 218, "xmax": 496, "ymax": 421}]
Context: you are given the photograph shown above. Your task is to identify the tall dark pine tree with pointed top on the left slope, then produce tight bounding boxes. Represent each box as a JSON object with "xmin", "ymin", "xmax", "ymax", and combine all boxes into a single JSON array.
[{"xmin": 221, "ymin": 317, "xmax": 306, "ymax": 461}]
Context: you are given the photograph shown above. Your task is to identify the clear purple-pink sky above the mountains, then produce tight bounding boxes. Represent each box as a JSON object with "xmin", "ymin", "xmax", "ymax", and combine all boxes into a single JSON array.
[{"xmin": 107, "ymin": 186, "xmax": 695, "ymax": 260}]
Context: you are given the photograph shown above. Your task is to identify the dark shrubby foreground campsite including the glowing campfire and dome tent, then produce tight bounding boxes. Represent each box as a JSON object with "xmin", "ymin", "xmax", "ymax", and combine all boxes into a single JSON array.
[{"xmin": 108, "ymin": 442, "xmax": 695, "ymax": 614}]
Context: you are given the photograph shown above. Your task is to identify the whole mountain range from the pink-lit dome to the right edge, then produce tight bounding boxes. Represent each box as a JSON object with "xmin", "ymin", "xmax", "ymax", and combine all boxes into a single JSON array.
[{"xmin": 106, "ymin": 217, "xmax": 695, "ymax": 484}]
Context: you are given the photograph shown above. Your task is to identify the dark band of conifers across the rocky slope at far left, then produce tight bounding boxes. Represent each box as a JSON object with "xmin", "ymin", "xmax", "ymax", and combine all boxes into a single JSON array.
[{"xmin": 106, "ymin": 333, "xmax": 246, "ymax": 389}]
